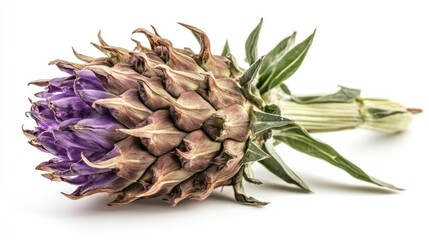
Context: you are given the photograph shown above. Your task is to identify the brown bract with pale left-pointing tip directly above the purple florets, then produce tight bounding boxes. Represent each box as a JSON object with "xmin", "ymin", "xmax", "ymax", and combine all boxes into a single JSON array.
[{"xmin": 86, "ymin": 64, "xmax": 139, "ymax": 95}]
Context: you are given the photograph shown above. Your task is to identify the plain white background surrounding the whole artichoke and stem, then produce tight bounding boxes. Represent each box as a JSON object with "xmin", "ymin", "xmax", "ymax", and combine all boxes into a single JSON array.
[{"xmin": 0, "ymin": 0, "xmax": 429, "ymax": 239}]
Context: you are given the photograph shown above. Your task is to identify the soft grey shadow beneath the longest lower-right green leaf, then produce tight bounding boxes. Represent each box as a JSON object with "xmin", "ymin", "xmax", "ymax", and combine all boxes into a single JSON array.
[{"xmin": 303, "ymin": 176, "xmax": 398, "ymax": 195}]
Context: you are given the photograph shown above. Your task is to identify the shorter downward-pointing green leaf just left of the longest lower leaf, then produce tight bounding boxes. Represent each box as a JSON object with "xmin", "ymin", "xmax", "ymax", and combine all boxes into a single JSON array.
[{"xmin": 259, "ymin": 139, "xmax": 311, "ymax": 192}]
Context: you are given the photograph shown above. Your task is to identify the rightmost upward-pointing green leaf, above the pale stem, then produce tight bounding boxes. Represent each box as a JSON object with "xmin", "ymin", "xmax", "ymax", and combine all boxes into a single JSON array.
[{"xmin": 257, "ymin": 31, "xmax": 316, "ymax": 95}]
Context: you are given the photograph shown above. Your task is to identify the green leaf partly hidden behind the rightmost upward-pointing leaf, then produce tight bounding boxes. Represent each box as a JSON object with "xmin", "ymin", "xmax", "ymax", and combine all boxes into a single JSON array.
[{"xmin": 260, "ymin": 32, "xmax": 296, "ymax": 74}]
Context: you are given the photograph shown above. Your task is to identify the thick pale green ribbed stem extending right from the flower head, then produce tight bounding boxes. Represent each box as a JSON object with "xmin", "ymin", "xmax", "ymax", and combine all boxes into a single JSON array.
[{"xmin": 265, "ymin": 88, "xmax": 421, "ymax": 133}]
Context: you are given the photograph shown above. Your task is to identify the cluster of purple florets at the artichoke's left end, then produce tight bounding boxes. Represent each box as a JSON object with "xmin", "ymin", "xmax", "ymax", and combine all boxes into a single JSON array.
[{"xmin": 24, "ymin": 64, "xmax": 126, "ymax": 197}]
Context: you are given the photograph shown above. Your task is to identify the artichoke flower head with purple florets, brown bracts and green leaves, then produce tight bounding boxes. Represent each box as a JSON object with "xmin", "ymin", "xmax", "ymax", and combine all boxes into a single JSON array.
[{"xmin": 24, "ymin": 21, "xmax": 398, "ymax": 206}]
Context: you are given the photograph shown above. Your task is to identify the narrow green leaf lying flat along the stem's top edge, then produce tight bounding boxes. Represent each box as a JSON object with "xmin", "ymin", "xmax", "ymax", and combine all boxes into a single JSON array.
[{"xmin": 291, "ymin": 86, "xmax": 360, "ymax": 104}]
